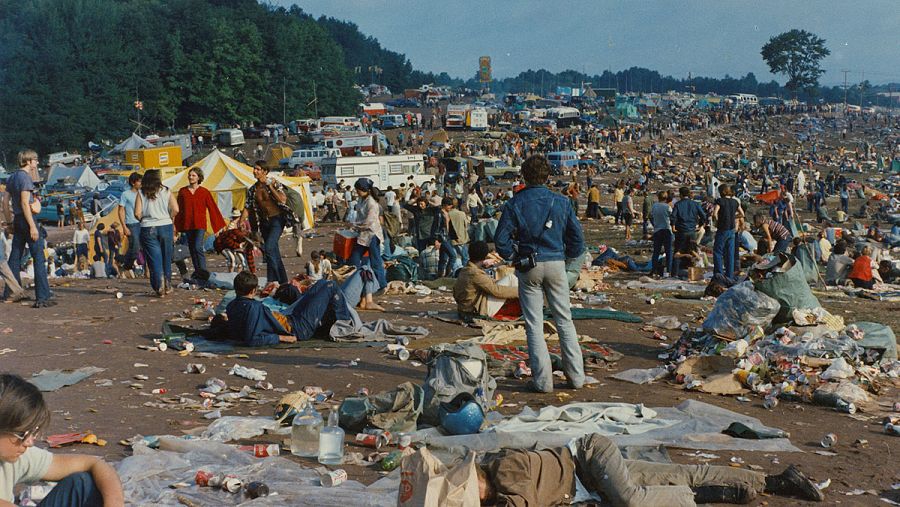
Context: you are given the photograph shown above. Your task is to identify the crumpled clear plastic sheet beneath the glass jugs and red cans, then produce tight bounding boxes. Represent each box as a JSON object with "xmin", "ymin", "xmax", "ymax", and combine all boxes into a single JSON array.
[{"xmin": 117, "ymin": 437, "xmax": 397, "ymax": 507}]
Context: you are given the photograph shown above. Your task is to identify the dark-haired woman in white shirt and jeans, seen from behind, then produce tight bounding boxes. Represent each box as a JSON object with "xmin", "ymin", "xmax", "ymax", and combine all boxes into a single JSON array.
[{"xmin": 134, "ymin": 169, "xmax": 178, "ymax": 297}]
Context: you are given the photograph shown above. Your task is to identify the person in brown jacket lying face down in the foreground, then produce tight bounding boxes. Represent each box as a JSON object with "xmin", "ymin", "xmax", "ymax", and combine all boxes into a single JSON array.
[{"xmin": 476, "ymin": 434, "xmax": 824, "ymax": 507}]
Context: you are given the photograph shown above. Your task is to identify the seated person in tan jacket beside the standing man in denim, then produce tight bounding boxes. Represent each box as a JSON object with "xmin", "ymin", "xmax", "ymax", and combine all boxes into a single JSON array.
[{"xmin": 453, "ymin": 241, "xmax": 519, "ymax": 321}]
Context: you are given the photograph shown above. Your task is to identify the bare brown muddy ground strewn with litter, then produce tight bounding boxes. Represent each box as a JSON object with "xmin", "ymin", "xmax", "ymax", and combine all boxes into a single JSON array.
[{"xmin": 0, "ymin": 117, "xmax": 900, "ymax": 505}]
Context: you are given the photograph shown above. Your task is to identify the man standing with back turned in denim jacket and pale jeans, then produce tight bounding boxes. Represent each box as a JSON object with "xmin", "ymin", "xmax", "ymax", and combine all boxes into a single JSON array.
[{"xmin": 495, "ymin": 155, "xmax": 584, "ymax": 393}]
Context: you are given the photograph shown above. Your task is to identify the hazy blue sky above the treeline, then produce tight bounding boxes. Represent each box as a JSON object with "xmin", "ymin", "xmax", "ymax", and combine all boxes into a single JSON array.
[{"xmin": 264, "ymin": 0, "xmax": 900, "ymax": 86}]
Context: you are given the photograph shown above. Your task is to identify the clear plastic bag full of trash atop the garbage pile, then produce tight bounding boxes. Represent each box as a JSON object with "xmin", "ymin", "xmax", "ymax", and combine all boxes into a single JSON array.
[{"xmin": 703, "ymin": 282, "xmax": 780, "ymax": 339}]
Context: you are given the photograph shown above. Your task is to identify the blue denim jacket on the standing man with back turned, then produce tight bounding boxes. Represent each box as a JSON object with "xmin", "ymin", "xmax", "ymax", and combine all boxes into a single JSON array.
[{"xmin": 494, "ymin": 185, "xmax": 585, "ymax": 262}]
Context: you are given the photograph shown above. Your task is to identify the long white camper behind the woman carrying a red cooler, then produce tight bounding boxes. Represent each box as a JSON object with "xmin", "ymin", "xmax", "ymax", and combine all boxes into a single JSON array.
[{"xmin": 322, "ymin": 155, "xmax": 432, "ymax": 190}]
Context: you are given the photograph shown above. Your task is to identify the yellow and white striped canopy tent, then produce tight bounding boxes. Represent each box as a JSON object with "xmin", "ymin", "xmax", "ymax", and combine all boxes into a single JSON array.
[{"xmin": 163, "ymin": 149, "xmax": 314, "ymax": 229}]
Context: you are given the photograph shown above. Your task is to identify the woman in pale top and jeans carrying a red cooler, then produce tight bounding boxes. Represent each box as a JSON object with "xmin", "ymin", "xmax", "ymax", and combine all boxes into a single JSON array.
[{"xmin": 349, "ymin": 178, "xmax": 387, "ymax": 288}]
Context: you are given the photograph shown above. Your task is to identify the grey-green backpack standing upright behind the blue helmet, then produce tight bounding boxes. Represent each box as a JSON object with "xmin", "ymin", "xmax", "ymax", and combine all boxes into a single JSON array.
[{"xmin": 422, "ymin": 343, "xmax": 497, "ymax": 425}]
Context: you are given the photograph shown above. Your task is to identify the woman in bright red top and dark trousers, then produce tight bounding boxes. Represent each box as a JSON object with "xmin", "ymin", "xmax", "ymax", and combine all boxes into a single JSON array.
[{"xmin": 175, "ymin": 167, "xmax": 225, "ymax": 275}]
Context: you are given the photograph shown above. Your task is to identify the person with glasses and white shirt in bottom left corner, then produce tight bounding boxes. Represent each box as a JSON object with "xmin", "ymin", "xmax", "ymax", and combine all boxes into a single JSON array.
[{"xmin": 0, "ymin": 373, "xmax": 125, "ymax": 507}]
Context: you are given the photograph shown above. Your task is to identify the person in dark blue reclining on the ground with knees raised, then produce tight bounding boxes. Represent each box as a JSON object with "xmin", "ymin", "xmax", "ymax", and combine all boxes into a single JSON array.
[{"xmin": 225, "ymin": 271, "xmax": 358, "ymax": 347}]
